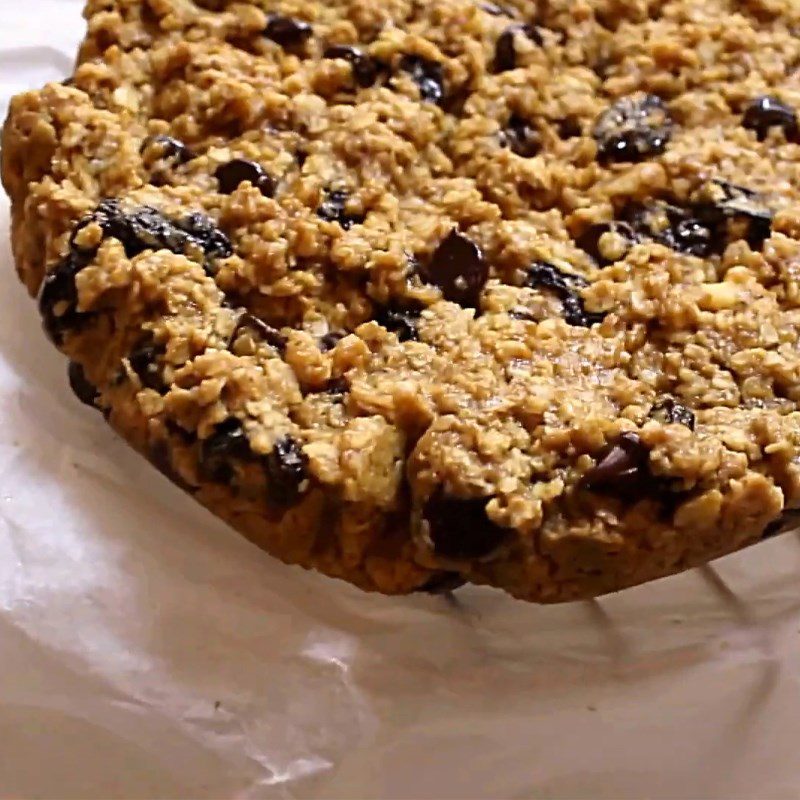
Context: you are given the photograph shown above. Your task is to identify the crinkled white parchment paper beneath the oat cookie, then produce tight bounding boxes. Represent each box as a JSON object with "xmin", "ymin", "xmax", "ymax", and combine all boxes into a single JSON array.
[{"xmin": 0, "ymin": 0, "xmax": 800, "ymax": 800}]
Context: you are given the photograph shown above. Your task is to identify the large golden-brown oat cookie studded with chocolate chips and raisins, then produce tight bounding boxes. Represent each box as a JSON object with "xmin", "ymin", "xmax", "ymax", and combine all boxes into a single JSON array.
[{"xmin": 2, "ymin": 0, "xmax": 800, "ymax": 602}]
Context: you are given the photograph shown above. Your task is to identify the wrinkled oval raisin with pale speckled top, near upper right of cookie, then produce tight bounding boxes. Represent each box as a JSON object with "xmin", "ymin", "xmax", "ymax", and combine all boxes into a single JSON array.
[{"xmin": 592, "ymin": 94, "xmax": 672, "ymax": 162}]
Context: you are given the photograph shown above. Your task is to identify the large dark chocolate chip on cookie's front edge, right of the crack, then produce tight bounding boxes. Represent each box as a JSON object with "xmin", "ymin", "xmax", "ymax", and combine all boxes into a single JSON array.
[{"xmin": 422, "ymin": 489, "xmax": 511, "ymax": 561}]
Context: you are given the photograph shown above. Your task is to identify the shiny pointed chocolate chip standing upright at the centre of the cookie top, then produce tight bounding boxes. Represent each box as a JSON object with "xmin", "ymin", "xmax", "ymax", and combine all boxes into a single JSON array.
[{"xmin": 423, "ymin": 230, "xmax": 489, "ymax": 308}]
